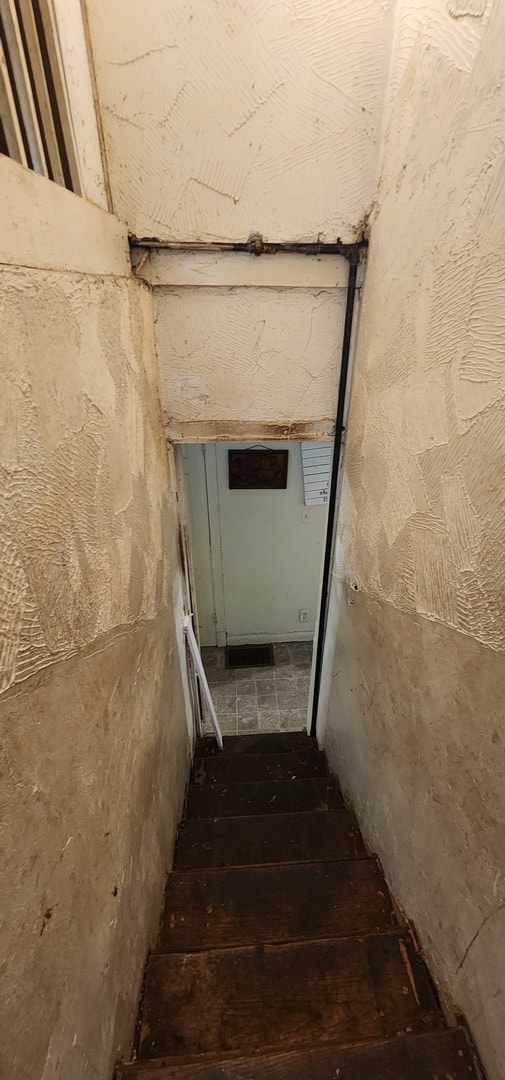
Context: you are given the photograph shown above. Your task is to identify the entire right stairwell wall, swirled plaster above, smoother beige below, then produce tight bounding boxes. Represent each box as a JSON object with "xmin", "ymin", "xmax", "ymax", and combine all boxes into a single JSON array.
[{"xmin": 322, "ymin": 0, "xmax": 505, "ymax": 1080}]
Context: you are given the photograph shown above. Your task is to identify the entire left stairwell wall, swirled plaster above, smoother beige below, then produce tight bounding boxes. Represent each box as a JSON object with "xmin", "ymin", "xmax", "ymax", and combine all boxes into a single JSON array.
[{"xmin": 0, "ymin": 159, "xmax": 188, "ymax": 1080}]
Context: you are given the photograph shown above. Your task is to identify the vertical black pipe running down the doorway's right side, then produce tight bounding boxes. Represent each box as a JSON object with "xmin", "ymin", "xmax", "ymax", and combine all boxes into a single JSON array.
[{"xmin": 311, "ymin": 252, "xmax": 359, "ymax": 737}]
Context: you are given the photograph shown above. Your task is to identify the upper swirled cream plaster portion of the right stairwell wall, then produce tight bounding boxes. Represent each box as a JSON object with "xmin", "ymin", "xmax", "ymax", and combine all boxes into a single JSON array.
[{"xmin": 336, "ymin": 0, "xmax": 505, "ymax": 648}]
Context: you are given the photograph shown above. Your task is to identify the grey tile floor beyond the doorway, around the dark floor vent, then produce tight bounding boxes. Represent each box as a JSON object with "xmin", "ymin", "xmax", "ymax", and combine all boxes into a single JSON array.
[{"xmin": 202, "ymin": 642, "xmax": 312, "ymax": 735}]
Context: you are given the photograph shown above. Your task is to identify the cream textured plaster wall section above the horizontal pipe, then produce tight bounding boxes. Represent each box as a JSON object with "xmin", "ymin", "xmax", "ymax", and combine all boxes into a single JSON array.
[{"xmin": 83, "ymin": 0, "xmax": 390, "ymax": 240}]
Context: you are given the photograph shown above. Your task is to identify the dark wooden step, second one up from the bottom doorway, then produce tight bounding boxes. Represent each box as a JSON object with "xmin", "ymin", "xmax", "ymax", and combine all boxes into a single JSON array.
[{"xmin": 191, "ymin": 750, "xmax": 329, "ymax": 784}]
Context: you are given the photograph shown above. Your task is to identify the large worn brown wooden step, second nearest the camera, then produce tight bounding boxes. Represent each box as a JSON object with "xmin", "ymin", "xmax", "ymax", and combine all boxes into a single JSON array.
[{"xmin": 139, "ymin": 932, "xmax": 442, "ymax": 1057}]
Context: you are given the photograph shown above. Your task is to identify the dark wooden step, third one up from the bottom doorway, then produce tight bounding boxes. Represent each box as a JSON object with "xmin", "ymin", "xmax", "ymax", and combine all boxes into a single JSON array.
[{"xmin": 186, "ymin": 777, "xmax": 343, "ymax": 820}]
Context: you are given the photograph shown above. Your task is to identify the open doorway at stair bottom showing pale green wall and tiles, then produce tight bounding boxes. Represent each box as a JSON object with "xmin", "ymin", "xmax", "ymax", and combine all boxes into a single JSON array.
[{"xmin": 180, "ymin": 442, "xmax": 332, "ymax": 734}]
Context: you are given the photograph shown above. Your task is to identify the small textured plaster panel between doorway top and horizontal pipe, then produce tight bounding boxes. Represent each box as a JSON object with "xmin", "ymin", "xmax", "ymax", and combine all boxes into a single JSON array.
[{"xmin": 154, "ymin": 287, "xmax": 345, "ymax": 441}]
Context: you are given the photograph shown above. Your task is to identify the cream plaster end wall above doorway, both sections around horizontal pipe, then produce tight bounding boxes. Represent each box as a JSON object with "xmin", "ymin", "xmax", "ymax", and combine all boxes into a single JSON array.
[{"xmin": 86, "ymin": 0, "xmax": 392, "ymax": 442}]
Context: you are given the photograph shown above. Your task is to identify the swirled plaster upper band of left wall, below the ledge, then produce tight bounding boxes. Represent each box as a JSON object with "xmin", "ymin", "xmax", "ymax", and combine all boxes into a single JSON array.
[{"xmin": 0, "ymin": 270, "xmax": 168, "ymax": 689}]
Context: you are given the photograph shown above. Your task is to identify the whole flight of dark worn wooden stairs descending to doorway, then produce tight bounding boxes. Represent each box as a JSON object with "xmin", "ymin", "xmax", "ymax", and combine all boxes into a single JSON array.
[{"xmin": 117, "ymin": 732, "xmax": 479, "ymax": 1080}]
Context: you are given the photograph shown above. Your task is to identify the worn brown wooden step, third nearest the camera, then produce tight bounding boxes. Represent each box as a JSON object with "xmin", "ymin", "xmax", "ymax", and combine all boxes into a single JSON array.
[{"xmin": 158, "ymin": 859, "xmax": 396, "ymax": 953}]
